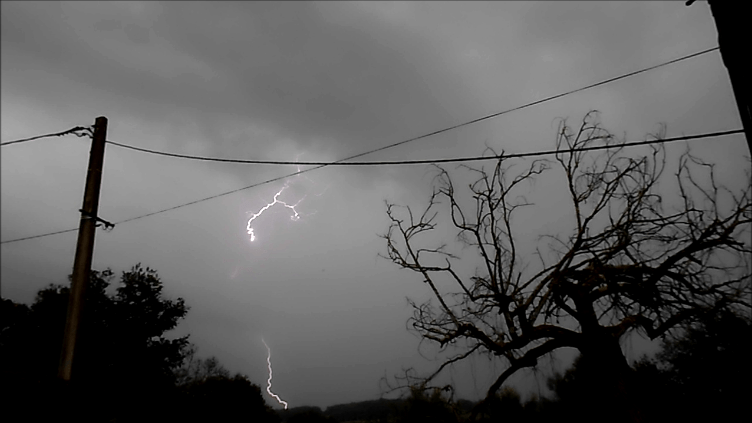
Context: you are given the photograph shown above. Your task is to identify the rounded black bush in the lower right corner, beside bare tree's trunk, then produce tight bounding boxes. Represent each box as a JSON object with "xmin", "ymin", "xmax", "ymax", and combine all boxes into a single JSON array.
[{"xmin": 635, "ymin": 312, "xmax": 752, "ymax": 421}]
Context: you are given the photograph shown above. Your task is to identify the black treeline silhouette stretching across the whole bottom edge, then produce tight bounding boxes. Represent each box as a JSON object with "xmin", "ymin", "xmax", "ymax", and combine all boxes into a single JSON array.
[{"xmin": 0, "ymin": 265, "xmax": 752, "ymax": 423}]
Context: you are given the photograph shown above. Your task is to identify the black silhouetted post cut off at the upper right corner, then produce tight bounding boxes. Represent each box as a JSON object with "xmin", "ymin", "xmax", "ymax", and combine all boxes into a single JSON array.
[{"xmin": 685, "ymin": 0, "xmax": 752, "ymax": 155}]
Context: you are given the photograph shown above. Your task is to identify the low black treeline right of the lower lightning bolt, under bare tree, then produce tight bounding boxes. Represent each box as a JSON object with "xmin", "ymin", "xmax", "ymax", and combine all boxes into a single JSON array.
[{"xmin": 280, "ymin": 313, "xmax": 752, "ymax": 423}]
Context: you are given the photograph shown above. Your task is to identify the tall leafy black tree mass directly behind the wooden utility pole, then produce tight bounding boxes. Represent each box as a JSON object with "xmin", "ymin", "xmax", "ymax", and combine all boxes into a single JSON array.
[{"xmin": 0, "ymin": 265, "xmax": 189, "ymax": 421}]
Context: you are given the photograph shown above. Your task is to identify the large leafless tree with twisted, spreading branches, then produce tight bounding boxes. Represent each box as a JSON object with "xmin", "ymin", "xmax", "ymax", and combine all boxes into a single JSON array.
[{"xmin": 384, "ymin": 112, "xmax": 752, "ymax": 421}]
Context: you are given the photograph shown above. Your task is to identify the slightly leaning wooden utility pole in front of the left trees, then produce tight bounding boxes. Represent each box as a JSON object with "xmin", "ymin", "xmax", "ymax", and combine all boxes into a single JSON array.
[{"xmin": 58, "ymin": 116, "xmax": 107, "ymax": 381}]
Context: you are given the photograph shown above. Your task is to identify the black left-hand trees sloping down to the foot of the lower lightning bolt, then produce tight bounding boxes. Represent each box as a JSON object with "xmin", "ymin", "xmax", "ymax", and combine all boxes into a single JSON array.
[{"xmin": 0, "ymin": 265, "xmax": 280, "ymax": 423}]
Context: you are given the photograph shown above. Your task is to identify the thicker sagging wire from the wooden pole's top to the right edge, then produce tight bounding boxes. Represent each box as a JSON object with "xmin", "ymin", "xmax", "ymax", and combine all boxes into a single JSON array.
[{"xmin": 107, "ymin": 129, "xmax": 744, "ymax": 166}]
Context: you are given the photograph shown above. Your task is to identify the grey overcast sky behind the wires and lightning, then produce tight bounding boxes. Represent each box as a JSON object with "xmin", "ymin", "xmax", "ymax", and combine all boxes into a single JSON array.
[{"xmin": 0, "ymin": 1, "xmax": 748, "ymax": 407}]
